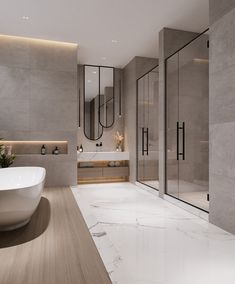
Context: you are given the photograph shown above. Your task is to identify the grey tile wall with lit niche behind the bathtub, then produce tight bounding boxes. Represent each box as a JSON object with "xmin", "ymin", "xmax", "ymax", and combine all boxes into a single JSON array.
[{"xmin": 0, "ymin": 36, "xmax": 77, "ymax": 186}]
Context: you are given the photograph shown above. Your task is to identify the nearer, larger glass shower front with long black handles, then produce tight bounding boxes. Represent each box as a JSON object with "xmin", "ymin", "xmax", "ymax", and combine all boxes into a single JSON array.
[{"xmin": 166, "ymin": 31, "xmax": 209, "ymax": 211}]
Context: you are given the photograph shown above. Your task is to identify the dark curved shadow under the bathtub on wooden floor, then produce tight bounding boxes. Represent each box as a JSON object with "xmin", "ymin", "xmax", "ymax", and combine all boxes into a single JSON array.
[{"xmin": 0, "ymin": 197, "xmax": 51, "ymax": 248}]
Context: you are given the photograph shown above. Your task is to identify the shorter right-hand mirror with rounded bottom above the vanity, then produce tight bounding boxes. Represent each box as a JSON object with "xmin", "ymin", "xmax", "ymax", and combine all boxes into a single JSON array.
[{"xmin": 99, "ymin": 67, "xmax": 115, "ymax": 128}]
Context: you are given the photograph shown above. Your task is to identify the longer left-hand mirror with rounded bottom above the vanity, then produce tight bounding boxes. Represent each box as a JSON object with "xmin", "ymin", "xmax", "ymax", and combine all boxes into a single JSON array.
[{"xmin": 84, "ymin": 65, "xmax": 103, "ymax": 140}]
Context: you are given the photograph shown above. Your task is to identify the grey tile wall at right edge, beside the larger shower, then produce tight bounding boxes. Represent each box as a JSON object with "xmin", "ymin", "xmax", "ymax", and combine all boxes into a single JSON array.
[{"xmin": 209, "ymin": 0, "xmax": 235, "ymax": 234}]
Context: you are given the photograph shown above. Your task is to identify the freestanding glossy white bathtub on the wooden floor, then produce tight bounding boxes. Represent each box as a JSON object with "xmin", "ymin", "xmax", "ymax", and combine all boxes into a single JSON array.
[{"xmin": 0, "ymin": 167, "xmax": 46, "ymax": 231}]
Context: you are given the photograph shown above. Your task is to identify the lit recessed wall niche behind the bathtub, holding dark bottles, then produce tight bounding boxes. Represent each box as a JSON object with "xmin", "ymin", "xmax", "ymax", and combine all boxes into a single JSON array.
[{"xmin": 0, "ymin": 140, "xmax": 68, "ymax": 156}]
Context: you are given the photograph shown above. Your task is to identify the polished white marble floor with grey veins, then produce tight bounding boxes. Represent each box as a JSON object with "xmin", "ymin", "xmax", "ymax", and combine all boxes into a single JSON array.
[{"xmin": 72, "ymin": 183, "xmax": 235, "ymax": 284}]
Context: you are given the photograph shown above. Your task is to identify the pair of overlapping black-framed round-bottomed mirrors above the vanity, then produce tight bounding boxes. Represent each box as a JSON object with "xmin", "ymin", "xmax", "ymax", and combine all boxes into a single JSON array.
[{"xmin": 83, "ymin": 65, "xmax": 115, "ymax": 140}]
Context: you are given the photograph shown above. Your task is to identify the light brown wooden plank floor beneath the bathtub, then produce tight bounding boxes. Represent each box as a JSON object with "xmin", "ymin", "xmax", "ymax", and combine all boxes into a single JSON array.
[{"xmin": 0, "ymin": 188, "xmax": 111, "ymax": 284}]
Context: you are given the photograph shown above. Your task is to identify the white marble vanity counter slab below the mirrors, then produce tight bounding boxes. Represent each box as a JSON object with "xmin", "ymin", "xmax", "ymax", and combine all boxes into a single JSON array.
[{"xmin": 77, "ymin": 152, "xmax": 129, "ymax": 162}]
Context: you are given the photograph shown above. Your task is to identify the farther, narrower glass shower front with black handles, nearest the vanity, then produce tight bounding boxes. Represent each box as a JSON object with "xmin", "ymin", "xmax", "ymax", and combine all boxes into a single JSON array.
[{"xmin": 137, "ymin": 67, "xmax": 159, "ymax": 189}]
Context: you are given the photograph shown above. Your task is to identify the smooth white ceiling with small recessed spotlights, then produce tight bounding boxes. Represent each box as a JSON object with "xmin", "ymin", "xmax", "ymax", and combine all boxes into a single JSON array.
[{"xmin": 0, "ymin": 0, "xmax": 209, "ymax": 67}]
